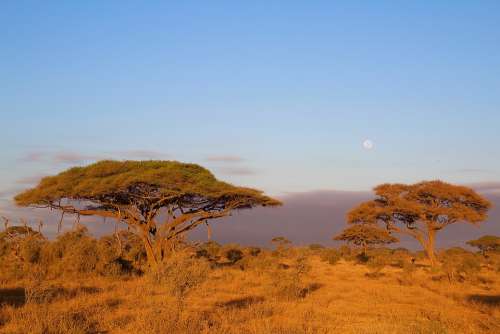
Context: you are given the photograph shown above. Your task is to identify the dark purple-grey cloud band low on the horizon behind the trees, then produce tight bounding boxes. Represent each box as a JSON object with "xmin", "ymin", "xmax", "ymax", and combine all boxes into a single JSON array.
[{"xmin": 0, "ymin": 188, "xmax": 500, "ymax": 249}]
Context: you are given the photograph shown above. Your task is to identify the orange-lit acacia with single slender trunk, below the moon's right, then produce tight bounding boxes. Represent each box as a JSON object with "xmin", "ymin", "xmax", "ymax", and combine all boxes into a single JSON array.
[{"xmin": 347, "ymin": 181, "xmax": 491, "ymax": 265}]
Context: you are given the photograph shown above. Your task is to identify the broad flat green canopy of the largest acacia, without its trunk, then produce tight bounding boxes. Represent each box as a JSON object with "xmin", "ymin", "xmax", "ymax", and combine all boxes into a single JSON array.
[{"xmin": 15, "ymin": 161, "xmax": 280, "ymax": 207}]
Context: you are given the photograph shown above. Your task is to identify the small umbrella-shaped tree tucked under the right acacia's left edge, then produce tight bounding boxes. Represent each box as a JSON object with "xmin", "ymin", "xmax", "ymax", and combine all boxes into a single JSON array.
[{"xmin": 333, "ymin": 224, "xmax": 399, "ymax": 256}]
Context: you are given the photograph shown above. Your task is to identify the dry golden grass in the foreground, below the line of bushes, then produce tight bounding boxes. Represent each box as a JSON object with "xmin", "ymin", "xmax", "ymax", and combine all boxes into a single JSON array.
[{"xmin": 0, "ymin": 254, "xmax": 500, "ymax": 334}]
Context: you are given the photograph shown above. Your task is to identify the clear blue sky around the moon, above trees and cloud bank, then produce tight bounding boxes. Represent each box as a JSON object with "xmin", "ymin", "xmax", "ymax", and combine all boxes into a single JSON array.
[{"xmin": 0, "ymin": 0, "xmax": 500, "ymax": 197}]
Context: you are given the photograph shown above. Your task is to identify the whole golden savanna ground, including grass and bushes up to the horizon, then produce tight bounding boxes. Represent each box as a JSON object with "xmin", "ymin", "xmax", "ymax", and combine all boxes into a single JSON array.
[{"xmin": 0, "ymin": 227, "xmax": 500, "ymax": 333}]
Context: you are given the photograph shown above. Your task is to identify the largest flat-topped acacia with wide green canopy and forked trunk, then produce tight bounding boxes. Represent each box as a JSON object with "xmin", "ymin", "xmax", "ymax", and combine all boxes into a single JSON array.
[{"xmin": 15, "ymin": 160, "xmax": 281, "ymax": 266}]
